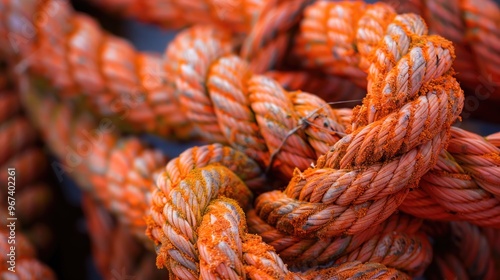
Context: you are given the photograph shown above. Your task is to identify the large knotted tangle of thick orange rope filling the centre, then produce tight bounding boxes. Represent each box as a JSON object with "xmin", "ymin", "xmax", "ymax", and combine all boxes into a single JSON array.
[{"xmin": 0, "ymin": 0, "xmax": 500, "ymax": 279}]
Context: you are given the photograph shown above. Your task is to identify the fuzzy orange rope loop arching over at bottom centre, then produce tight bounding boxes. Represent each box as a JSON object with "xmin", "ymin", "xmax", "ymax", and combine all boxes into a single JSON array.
[{"xmin": 148, "ymin": 144, "xmax": 403, "ymax": 279}]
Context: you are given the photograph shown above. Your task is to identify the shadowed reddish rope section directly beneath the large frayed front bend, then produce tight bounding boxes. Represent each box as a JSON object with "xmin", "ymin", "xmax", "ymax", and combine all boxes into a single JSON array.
[{"xmin": 247, "ymin": 211, "xmax": 432, "ymax": 275}]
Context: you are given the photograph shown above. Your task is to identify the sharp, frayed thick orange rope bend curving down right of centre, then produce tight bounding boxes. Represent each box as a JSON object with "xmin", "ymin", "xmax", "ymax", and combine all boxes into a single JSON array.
[{"xmin": 250, "ymin": 4, "xmax": 463, "ymax": 237}]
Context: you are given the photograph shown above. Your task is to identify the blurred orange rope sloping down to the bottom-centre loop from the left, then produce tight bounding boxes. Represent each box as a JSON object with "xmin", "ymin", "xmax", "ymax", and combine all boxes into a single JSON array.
[{"xmin": 21, "ymin": 79, "xmax": 166, "ymax": 245}]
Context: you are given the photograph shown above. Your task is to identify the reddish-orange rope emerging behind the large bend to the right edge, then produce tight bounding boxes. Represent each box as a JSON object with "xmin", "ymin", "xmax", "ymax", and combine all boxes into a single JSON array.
[{"xmin": 400, "ymin": 128, "xmax": 500, "ymax": 228}]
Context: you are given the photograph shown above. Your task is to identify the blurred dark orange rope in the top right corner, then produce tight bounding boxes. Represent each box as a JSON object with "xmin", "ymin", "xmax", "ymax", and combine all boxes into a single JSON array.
[{"xmin": 385, "ymin": 0, "xmax": 500, "ymax": 100}]
